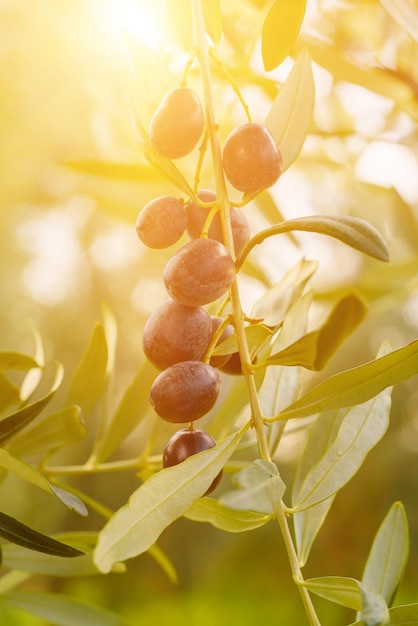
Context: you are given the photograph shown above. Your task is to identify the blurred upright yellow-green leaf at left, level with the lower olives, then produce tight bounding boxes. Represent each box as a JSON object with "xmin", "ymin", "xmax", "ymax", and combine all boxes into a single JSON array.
[{"xmin": 67, "ymin": 322, "xmax": 108, "ymax": 417}]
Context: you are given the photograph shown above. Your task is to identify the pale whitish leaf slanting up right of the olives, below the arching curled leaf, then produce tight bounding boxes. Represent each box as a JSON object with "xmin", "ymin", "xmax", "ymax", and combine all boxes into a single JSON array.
[{"xmin": 251, "ymin": 259, "xmax": 318, "ymax": 326}]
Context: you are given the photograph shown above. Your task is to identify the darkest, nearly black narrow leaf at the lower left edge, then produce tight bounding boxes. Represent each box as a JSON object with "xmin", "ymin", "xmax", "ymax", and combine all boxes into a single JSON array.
[{"xmin": 0, "ymin": 512, "xmax": 84, "ymax": 558}]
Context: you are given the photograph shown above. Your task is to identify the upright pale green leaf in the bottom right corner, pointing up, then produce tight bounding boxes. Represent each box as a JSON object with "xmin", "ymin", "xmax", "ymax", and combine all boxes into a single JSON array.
[{"xmin": 362, "ymin": 502, "xmax": 409, "ymax": 606}]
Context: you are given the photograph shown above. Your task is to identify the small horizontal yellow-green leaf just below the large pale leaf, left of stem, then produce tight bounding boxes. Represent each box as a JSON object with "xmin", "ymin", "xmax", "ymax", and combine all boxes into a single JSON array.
[{"xmin": 184, "ymin": 498, "xmax": 272, "ymax": 533}]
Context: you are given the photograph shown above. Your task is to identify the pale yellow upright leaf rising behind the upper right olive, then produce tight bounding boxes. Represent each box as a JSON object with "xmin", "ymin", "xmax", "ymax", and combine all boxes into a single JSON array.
[{"xmin": 264, "ymin": 50, "xmax": 315, "ymax": 171}]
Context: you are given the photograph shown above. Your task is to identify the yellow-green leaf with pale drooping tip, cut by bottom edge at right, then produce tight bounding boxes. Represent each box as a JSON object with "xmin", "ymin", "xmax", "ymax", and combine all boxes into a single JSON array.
[{"xmin": 303, "ymin": 576, "xmax": 390, "ymax": 626}]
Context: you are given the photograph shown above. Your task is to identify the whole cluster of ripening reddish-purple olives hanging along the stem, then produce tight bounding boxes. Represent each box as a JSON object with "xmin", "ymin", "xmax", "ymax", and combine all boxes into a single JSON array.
[{"xmin": 136, "ymin": 87, "xmax": 282, "ymax": 492}]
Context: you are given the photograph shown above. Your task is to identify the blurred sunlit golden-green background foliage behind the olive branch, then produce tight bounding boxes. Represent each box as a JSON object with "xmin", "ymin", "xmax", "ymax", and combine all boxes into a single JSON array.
[{"xmin": 0, "ymin": 0, "xmax": 418, "ymax": 626}]
